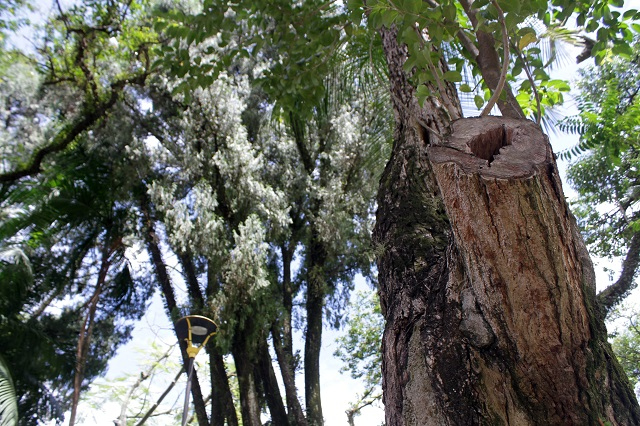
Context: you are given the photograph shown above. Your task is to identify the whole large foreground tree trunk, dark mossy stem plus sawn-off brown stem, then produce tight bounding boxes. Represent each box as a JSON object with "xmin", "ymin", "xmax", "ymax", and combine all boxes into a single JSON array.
[{"xmin": 374, "ymin": 25, "xmax": 640, "ymax": 426}]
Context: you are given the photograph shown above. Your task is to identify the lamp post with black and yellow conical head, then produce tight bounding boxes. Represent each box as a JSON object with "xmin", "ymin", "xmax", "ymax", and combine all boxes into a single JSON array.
[{"xmin": 176, "ymin": 315, "xmax": 218, "ymax": 426}]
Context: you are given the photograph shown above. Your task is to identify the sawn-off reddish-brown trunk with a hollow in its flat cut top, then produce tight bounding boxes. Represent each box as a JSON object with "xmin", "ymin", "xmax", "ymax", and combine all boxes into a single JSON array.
[{"xmin": 428, "ymin": 117, "xmax": 637, "ymax": 424}]
